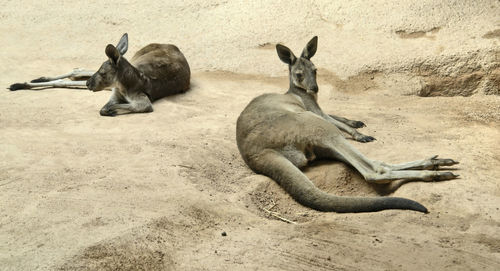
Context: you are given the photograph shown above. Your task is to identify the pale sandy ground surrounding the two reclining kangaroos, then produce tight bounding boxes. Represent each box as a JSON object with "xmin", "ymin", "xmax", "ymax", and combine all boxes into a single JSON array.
[{"xmin": 0, "ymin": 0, "xmax": 500, "ymax": 270}]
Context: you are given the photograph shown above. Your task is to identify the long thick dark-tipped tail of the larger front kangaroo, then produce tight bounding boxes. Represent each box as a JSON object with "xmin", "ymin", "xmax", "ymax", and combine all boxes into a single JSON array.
[{"xmin": 254, "ymin": 151, "xmax": 428, "ymax": 213}]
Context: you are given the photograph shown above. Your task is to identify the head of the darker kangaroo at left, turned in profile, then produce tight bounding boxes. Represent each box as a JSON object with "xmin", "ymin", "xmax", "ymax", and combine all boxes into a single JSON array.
[{"xmin": 87, "ymin": 33, "xmax": 128, "ymax": 91}]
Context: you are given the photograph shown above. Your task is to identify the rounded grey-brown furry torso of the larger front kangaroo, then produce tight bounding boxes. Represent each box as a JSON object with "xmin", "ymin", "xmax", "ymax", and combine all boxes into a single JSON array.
[{"xmin": 236, "ymin": 93, "xmax": 341, "ymax": 164}]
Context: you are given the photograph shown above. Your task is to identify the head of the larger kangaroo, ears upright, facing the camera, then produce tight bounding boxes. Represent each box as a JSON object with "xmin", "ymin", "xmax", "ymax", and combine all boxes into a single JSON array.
[{"xmin": 276, "ymin": 36, "xmax": 318, "ymax": 95}]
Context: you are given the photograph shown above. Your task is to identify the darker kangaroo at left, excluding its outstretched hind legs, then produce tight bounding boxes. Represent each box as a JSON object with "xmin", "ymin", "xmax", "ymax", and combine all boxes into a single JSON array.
[{"xmin": 86, "ymin": 33, "xmax": 191, "ymax": 116}]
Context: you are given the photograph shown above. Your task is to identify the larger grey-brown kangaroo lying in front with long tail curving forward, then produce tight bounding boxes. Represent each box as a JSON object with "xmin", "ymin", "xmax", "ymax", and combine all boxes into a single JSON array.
[{"xmin": 236, "ymin": 37, "xmax": 458, "ymax": 213}]
